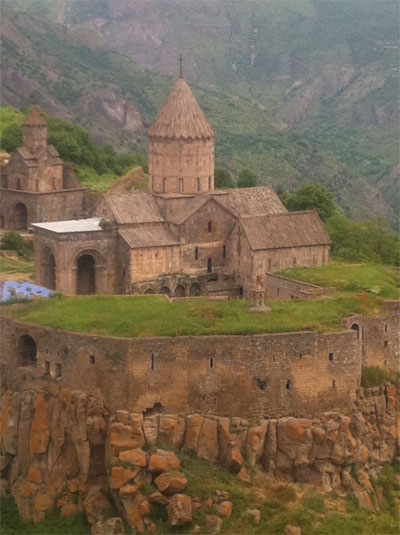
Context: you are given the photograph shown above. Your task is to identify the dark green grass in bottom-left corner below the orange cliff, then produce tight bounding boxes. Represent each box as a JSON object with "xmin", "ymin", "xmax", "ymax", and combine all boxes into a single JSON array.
[{"xmin": 0, "ymin": 495, "xmax": 90, "ymax": 535}]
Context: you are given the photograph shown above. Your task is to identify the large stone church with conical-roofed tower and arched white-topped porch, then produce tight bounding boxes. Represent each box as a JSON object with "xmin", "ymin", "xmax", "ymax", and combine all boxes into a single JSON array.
[{"xmin": 30, "ymin": 76, "xmax": 330, "ymax": 297}]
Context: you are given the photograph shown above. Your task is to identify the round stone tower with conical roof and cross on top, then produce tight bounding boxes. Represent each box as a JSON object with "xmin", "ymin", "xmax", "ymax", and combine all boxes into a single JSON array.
[{"xmin": 148, "ymin": 60, "xmax": 215, "ymax": 195}]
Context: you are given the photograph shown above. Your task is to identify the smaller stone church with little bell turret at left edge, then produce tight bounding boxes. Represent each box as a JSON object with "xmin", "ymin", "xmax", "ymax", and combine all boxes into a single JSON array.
[{"xmin": 0, "ymin": 108, "xmax": 86, "ymax": 230}]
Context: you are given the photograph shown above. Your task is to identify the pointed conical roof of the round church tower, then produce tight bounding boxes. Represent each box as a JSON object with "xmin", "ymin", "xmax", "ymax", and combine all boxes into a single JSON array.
[{"xmin": 148, "ymin": 77, "xmax": 215, "ymax": 139}]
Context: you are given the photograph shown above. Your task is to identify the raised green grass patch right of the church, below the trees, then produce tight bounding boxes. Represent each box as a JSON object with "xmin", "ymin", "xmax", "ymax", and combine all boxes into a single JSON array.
[{"xmin": 279, "ymin": 262, "xmax": 400, "ymax": 299}]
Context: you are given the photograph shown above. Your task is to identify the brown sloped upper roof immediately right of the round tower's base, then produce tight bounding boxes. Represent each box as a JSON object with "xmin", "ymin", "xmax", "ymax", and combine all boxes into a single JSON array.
[{"xmin": 211, "ymin": 186, "xmax": 287, "ymax": 217}]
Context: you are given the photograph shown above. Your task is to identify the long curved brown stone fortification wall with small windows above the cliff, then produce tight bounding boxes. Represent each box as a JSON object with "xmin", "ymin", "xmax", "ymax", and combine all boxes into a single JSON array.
[{"xmin": 1, "ymin": 317, "xmax": 361, "ymax": 417}]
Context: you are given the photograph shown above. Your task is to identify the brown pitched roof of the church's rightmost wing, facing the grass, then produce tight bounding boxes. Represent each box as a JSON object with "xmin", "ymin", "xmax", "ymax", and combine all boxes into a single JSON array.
[{"xmin": 240, "ymin": 210, "xmax": 331, "ymax": 250}]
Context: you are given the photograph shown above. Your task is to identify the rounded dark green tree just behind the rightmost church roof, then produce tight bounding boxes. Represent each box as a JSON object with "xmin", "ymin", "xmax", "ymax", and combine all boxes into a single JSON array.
[{"xmin": 285, "ymin": 182, "xmax": 336, "ymax": 221}]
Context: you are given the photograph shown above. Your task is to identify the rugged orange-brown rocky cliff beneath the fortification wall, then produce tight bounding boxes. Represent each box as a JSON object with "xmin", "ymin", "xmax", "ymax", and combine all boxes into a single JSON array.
[{"xmin": 1, "ymin": 384, "xmax": 399, "ymax": 533}]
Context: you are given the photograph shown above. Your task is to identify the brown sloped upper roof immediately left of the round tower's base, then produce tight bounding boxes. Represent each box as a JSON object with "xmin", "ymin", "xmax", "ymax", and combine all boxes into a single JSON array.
[{"xmin": 104, "ymin": 191, "xmax": 164, "ymax": 225}]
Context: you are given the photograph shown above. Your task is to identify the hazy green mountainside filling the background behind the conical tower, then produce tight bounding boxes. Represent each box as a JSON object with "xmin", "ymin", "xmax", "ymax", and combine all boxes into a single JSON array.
[{"xmin": 2, "ymin": 0, "xmax": 397, "ymax": 224}]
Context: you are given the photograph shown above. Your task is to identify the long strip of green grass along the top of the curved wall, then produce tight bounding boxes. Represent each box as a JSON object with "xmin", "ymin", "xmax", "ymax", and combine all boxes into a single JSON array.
[{"xmin": 3, "ymin": 294, "xmax": 379, "ymax": 337}]
